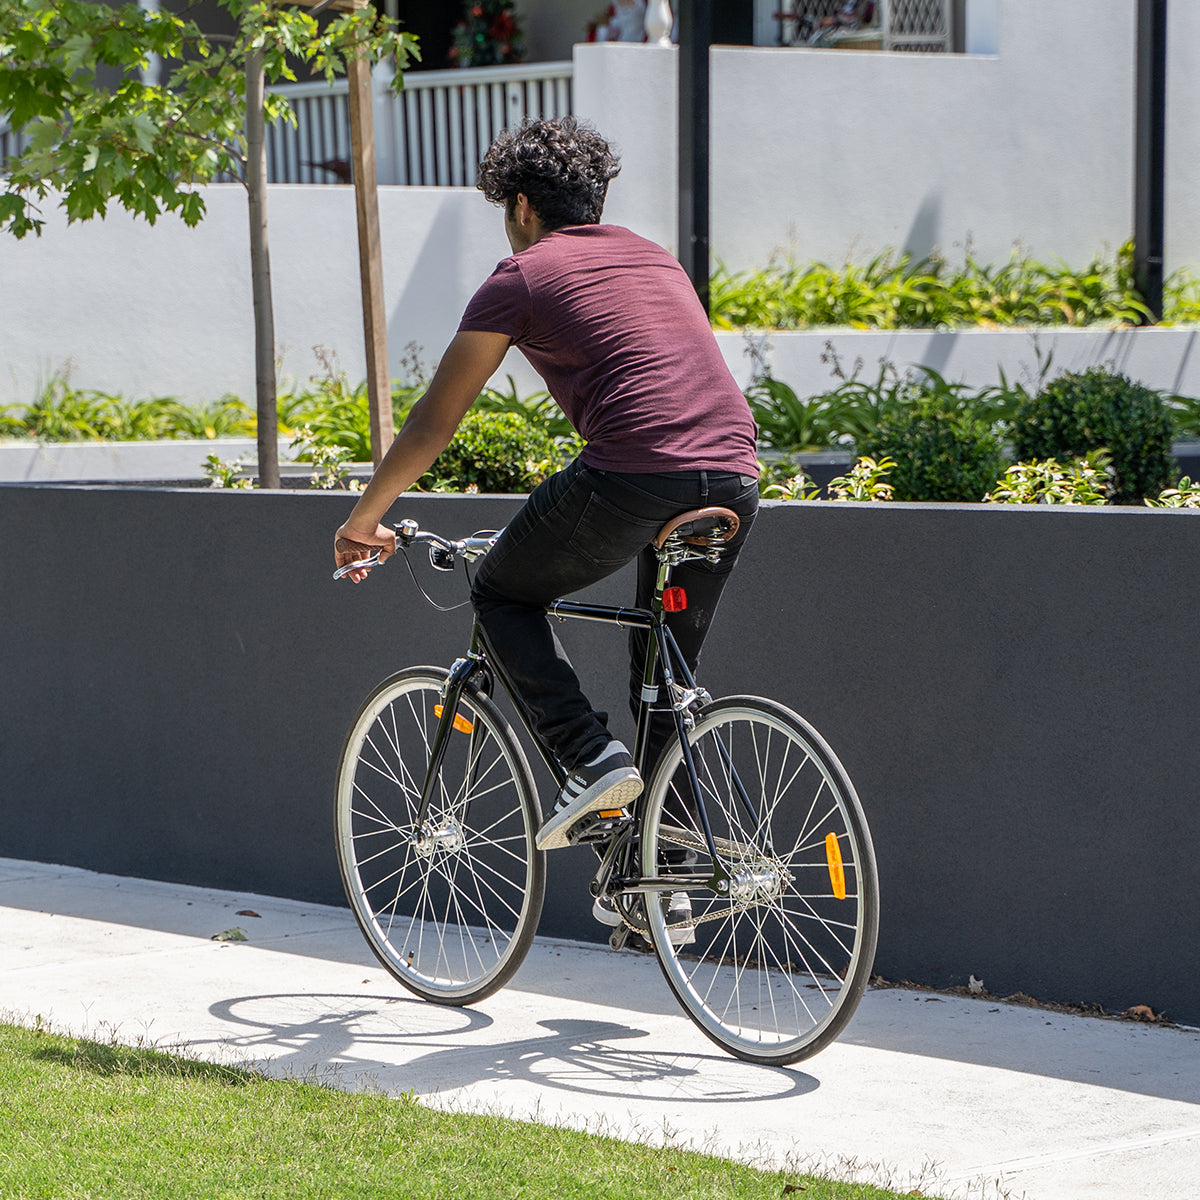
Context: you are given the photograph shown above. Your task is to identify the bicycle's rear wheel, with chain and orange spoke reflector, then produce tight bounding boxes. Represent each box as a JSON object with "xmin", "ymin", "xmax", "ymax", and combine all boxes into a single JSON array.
[{"xmin": 642, "ymin": 696, "xmax": 878, "ymax": 1064}]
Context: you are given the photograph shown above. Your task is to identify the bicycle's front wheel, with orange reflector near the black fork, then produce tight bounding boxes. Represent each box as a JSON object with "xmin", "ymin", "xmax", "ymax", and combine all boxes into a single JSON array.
[{"xmin": 336, "ymin": 667, "xmax": 546, "ymax": 1004}]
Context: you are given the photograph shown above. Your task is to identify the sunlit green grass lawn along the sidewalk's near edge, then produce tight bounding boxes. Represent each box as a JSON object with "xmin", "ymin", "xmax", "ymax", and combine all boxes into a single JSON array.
[{"xmin": 0, "ymin": 1024, "xmax": 916, "ymax": 1200}]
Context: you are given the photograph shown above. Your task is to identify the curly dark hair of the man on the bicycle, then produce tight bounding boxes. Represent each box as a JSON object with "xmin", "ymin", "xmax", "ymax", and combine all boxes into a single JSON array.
[{"xmin": 475, "ymin": 116, "xmax": 620, "ymax": 229}]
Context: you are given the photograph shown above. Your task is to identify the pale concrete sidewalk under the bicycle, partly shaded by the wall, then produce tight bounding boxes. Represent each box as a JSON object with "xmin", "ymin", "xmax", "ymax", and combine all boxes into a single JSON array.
[{"xmin": 0, "ymin": 859, "xmax": 1200, "ymax": 1200}]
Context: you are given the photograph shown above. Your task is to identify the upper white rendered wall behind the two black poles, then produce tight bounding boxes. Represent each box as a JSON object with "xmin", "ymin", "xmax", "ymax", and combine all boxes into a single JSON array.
[{"xmin": 575, "ymin": 0, "xmax": 1200, "ymax": 269}]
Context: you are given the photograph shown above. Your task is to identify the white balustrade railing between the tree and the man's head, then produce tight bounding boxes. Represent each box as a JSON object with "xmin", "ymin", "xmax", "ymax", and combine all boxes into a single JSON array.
[{"xmin": 268, "ymin": 62, "xmax": 572, "ymax": 187}]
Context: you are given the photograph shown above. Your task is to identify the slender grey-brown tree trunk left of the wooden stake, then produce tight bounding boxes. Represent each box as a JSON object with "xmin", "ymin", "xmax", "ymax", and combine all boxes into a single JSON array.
[{"xmin": 246, "ymin": 50, "xmax": 280, "ymax": 487}]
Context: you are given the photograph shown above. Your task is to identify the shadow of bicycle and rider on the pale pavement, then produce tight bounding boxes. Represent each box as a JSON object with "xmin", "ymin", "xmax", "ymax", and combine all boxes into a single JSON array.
[{"xmin": 208, "ymin": 994, "xmax": 820, "ymax": 1104}]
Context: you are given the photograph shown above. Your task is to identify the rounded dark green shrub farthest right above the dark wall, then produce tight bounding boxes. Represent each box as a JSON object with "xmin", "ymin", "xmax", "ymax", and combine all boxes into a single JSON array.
[{"xmin": 1013, "ymin": 367, "xmax": 1175, "ymax": 504}]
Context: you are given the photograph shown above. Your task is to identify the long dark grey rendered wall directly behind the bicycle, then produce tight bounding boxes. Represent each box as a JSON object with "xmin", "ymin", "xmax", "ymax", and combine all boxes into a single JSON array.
[{"xmin": 0, "ymin": 486, "xmax": 1200, "ymax": 1022}]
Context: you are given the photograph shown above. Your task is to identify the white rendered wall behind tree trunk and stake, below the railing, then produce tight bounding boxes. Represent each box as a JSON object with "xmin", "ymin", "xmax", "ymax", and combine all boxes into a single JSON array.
[{"xmin": 0, "ymin": 185, "xmax": 528, "ymax": 404}]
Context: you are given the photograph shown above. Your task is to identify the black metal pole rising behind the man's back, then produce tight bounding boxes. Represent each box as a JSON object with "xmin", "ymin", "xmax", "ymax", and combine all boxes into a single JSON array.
[{"xmin": 678, "ymin": 0, "xmax": 713, "ymax": 312}]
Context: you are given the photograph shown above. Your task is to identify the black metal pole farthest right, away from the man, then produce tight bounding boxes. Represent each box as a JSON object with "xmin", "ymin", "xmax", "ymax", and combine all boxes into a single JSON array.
[{"xmin": 1133, "ymin": 0, "xmax": 1166, "ymax": 320}]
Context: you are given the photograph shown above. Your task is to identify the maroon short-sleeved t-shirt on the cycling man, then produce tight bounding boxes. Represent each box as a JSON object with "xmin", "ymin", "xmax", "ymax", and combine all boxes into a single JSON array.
[{"xmin": 458, "ymin": 226, "xmax": 758, "ymax": 475}]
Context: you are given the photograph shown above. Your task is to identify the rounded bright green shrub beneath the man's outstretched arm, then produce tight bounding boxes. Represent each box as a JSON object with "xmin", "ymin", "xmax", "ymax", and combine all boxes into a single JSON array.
[{"xmin": 420, "ymin": 413, "xmax": 564, "ymax": 492}]
